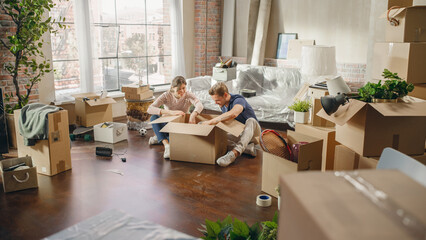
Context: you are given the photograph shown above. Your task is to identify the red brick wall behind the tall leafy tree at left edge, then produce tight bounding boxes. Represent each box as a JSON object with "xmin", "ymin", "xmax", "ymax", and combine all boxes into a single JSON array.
[{"xmin": 0, "ymin": 10, "xmax": 38, "ymax": 104}]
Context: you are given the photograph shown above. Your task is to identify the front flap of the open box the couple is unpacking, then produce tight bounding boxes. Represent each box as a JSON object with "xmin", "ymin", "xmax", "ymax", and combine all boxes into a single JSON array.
[{"xmin": 160, "ymin": 122, "xmax": 215, "ymax": 137}]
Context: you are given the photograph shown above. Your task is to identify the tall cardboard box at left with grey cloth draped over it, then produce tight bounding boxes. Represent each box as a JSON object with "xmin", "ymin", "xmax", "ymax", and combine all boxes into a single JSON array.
[{"xmin": 14, "ymin": 110, "xmax": 71, "ymax": 176}]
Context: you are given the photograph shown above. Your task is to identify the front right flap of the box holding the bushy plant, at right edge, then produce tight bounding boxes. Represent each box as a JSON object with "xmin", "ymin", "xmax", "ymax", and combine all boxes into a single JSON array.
[{"xmin": 370, "ymin": 102, "xmax": 426, "ymax": 117}]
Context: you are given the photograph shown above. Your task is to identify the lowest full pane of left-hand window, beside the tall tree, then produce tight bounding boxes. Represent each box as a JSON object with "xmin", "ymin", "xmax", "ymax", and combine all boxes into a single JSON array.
[{"xmin": 53, "ymin": 61, "xmax": 80, "ymax": 96}]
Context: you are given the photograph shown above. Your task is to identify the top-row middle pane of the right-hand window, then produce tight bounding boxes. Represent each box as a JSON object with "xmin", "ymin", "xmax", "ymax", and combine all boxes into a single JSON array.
[{"xmin": 117, "ymin": 0, "xmax": 145, "ymax": 24}]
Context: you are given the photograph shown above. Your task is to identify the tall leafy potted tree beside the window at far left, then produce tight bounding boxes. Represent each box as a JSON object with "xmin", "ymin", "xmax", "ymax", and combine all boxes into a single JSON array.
[{"xmin": 0, "ymin": 0, "xmax": 65, "ymax": 147}]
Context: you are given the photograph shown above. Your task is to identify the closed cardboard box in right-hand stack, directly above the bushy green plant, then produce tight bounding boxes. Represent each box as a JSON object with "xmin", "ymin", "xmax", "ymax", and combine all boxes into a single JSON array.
[{"xmin": 372, "ymin": 43, "xmax": 426, "ymax": 83}]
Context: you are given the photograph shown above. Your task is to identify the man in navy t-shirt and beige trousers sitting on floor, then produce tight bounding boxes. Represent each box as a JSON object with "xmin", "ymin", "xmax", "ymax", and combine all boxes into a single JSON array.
[{"xmin": 203, "ymin": 82, "xmax": 261, "ymax": 167}]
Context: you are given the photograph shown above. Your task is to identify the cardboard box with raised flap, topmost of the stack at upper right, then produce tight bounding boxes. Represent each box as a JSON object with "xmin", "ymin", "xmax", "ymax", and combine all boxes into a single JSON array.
[{"xmin": 381, "ymin": 6, "xmax": 426, "ymax": 42}]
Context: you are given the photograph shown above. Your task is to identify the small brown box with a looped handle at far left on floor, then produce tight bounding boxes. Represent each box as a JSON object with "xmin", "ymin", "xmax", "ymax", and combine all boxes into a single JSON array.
[{"xmin": 0, "ymin": 156, "xmax": 38, "ymax": 192}]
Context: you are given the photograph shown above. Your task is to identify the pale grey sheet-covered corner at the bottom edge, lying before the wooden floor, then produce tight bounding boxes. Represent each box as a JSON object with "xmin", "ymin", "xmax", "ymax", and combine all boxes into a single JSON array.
[{"xmin": 44, "ymin": 210, "xmax": 198, "ymax": 240}]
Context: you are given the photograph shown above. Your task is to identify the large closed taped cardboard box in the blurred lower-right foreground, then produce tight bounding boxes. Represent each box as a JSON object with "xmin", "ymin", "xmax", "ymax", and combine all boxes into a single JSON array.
[{"xmin": 278, "ymin": 170, "xmax": 426, "ymax": 240}]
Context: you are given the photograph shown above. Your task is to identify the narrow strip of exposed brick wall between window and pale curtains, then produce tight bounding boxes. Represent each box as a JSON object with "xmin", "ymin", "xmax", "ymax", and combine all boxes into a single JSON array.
[{"xmin": 194, "ymin": 0, "xmax": 222, "ymax": 76}]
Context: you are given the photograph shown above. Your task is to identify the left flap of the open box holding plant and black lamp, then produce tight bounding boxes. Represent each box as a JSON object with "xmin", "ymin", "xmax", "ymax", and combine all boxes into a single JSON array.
[{"xmin": 317, "ymin": 99, "xmax": 367, "ymax": 126}]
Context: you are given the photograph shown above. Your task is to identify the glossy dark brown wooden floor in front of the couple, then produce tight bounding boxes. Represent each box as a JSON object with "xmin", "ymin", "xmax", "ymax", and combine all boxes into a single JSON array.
[{"xmin": 0, "ymin": 127, "xmax": 277, "ymax": 239}]
